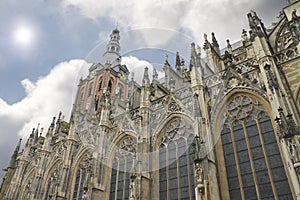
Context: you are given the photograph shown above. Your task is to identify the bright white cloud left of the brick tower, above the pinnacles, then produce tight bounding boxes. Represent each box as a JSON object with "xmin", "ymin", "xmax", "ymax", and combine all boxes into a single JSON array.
[{"xmin": 0, "ymin": 60, "xmax": 88, "ymax": 138}]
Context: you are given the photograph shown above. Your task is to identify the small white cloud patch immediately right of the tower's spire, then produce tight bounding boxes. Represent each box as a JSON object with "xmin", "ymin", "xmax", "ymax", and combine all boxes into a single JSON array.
[{"xmin": 122, "ymin": 56, "xmax": 163, "ymax": 84}]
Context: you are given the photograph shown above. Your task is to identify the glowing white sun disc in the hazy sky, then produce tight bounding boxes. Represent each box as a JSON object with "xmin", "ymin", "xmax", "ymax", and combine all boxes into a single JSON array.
[{"xmin": 14, "ymin": 26, "xmax": 33, "ymax": 46}]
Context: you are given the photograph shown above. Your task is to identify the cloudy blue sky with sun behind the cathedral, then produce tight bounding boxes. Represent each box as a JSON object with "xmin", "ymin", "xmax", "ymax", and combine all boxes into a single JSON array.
[{"xmin": 0, "ymin": 0, "xmax": 287, "ymax": 178}]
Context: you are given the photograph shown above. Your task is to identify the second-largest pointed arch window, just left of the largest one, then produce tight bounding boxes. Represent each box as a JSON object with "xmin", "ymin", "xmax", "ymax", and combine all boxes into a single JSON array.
[{"xmin": 159, "ymin": 119, "xmax": 195, "ymax": 199}]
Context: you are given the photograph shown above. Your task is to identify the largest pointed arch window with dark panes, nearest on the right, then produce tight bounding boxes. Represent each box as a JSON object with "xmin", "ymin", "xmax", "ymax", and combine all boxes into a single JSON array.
[{"xmin": 221, "ymin": 95, "xmax": 292, "ymax": 199}]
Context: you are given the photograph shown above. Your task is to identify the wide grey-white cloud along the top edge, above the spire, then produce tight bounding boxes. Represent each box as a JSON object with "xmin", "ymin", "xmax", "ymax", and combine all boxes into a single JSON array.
[{"xmin": 62, "ymin": 0, "xmax": 286, "ymax": 47}]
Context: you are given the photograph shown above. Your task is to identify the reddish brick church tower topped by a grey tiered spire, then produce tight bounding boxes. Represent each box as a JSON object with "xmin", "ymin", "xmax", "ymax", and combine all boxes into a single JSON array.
[{"xmin": 75, "ymin": 29, "xmax": 129, "ymax": 111}]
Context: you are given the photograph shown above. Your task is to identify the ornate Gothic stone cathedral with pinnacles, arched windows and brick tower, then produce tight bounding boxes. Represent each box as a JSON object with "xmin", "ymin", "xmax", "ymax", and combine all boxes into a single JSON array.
[{"xmin": 0, "ymin": 0, "xmax": 300, "ymax": 200}]
